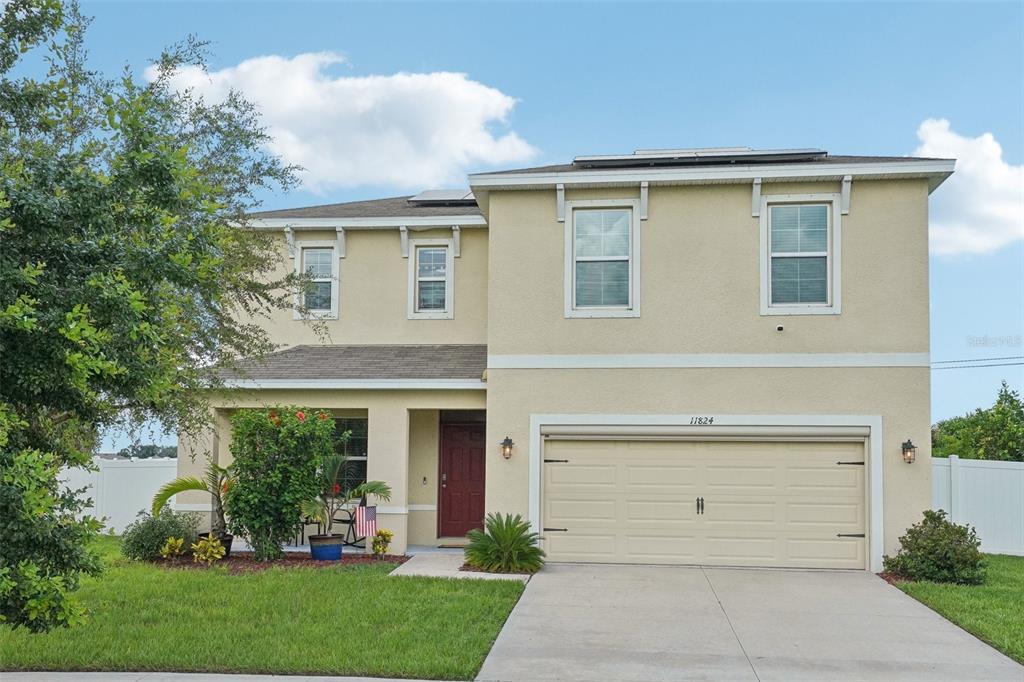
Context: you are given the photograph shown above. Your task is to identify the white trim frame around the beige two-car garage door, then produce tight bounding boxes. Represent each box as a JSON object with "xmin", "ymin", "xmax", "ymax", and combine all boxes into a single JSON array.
[{"xmin": 527, "ymin": 414, "xmax": 885, "ymax": 572}]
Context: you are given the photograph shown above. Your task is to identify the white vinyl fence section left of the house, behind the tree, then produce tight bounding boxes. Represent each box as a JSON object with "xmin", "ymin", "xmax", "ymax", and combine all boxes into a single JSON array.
[{"xmin": 60, "ymin": 457, "xmax": 178, "ymax": 532}]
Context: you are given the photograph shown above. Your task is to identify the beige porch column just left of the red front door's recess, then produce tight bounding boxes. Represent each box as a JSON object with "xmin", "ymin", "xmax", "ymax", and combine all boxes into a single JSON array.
[{"xmin": 367, "ymin": 406, "xmax": 409, "ymax": 554}]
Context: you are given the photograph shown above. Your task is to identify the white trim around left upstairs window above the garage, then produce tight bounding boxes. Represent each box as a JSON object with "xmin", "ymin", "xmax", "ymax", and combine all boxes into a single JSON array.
[{"xmin": 564, "ymin": 199, "xmax": 640, "ymax": 318}]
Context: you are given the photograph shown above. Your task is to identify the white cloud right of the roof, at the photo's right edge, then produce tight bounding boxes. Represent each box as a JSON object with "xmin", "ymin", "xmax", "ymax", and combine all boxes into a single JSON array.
[{"xmin": 914, "ymin": 119, "xmax": 1024, "ymax": 255}]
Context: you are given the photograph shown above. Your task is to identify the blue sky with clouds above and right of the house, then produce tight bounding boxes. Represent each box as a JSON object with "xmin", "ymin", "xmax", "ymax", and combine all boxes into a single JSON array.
[{"xmin": 68, "ymin": 2, "xmax": 1024, "ymax": 444}]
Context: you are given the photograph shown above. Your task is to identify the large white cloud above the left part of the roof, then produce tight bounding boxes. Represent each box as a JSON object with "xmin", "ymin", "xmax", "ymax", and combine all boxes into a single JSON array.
[{"xmin": 146, "ymin": 52, "xmax": 537, "ymax": 194}]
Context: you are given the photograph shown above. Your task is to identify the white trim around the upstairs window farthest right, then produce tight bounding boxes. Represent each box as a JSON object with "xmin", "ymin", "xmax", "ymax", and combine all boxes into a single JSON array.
[{"xmin": 760, "ymin": 193, "xmax": 843, "ymax": 315}]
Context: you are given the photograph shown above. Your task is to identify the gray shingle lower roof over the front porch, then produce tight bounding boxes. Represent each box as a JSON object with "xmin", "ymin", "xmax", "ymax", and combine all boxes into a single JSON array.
[{"xmin": 223, "ymin": 344, "xmax": 487, "ymax": 381}]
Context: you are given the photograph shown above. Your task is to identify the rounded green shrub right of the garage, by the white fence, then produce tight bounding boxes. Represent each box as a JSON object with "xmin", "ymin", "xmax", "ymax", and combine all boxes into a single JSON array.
[{"xmin": 884, "ymin": 510, "xmax": 985, "ymax": 585}]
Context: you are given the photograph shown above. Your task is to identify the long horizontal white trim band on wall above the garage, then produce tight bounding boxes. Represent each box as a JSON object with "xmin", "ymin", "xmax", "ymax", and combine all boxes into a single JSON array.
[{"xmin": 487, "ymin": 353, "xmax": 931, "ymax": 370}]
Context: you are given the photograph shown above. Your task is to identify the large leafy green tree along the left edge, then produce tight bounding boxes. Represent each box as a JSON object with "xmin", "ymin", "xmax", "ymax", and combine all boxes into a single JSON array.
[{"xmin": 0, "ymin": 0, "xmax": 296, "ymax": 631}]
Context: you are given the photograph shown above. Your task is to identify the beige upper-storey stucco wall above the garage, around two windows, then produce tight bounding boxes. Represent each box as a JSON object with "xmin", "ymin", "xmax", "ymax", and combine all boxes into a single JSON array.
[{"xmin": 488, "ymin": 179, "xmax": 929, "ymax": 354}]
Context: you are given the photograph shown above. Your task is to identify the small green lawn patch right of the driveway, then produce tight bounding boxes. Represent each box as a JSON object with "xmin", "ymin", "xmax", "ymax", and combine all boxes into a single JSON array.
[{"xmin": 899, "ymin": 554, "xmax": 1024, "ymax": 664}]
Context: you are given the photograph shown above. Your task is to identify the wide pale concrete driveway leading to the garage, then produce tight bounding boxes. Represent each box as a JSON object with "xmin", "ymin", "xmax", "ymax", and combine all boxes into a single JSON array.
[{"xmin": 477, "ymin": 564, "xmax": 1024, "ymax": 682}]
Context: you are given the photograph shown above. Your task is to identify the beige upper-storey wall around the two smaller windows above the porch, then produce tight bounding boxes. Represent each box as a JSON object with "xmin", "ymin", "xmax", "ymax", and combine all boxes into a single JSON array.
[{"xmin": 260, "ymin": 227, "xmax": 487, "ymax": 346}]
